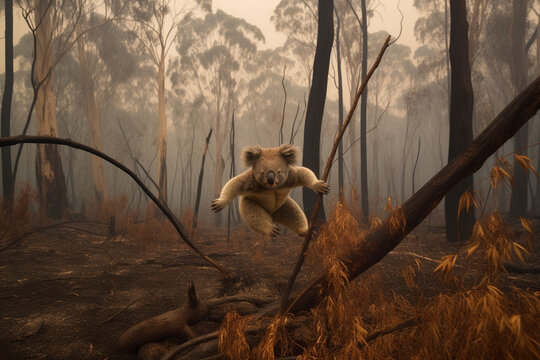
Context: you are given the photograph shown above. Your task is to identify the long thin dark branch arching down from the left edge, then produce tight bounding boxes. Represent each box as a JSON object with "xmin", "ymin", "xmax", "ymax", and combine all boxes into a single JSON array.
[{"xmin": 0, "ymin": 135, "xmax": 230, "ymax": 278}]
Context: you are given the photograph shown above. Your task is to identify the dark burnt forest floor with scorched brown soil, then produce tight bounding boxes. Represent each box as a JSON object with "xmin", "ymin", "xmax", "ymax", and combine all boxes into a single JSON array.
[{"xmin": 0, "ymin": 218, "xmax": 540, "ymax": 359}]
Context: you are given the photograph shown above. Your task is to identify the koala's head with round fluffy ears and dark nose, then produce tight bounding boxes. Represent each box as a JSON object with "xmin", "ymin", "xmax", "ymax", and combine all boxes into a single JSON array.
[{"xmin": 242, "ymin": 145, "xmax": 298, "ymax": 189}]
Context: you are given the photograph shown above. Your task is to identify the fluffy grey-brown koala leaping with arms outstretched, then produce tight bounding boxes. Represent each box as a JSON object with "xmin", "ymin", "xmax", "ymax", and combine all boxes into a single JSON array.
[{"xmin": 211, "ymin": 145, "xmax": 330, "ymax": 237}]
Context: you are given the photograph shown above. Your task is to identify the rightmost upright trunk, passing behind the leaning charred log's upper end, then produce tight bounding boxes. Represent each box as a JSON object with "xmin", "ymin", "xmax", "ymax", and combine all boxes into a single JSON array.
[{"xmin": 510, "ymin": 0, "xmax": 528, "ymax": 218}]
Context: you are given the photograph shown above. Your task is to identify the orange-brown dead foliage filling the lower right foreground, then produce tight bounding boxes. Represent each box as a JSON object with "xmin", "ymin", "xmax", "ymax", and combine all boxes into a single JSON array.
[{"xmin": 220, "ymin": 188, "xmax": 540, "ymax": 359}]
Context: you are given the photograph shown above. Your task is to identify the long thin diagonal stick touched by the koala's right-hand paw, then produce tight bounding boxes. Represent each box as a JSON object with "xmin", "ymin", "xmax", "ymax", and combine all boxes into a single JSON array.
[{"xmin": 280, "ymin": 35, "xmax": 390, "ymax": 314}]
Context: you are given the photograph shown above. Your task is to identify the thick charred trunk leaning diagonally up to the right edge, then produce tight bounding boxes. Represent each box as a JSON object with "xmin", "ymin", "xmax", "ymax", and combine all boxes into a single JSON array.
[{"xmin": 289, "ymin": 77, "xmax": 540, "ymax": 313}]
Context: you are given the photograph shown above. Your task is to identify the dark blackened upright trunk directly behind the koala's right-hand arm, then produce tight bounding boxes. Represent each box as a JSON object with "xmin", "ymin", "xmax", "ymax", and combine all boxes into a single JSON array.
[{"xmin": 302, "ymin": 0, "xmax": 334, "ymax": 220}]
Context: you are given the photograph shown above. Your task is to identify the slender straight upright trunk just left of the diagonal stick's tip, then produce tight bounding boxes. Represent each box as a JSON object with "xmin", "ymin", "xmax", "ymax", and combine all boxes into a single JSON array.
[{"xmin": 360, "ymin": 0, "xmax": 369, "ymax": 221}]
